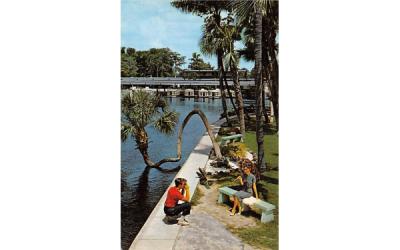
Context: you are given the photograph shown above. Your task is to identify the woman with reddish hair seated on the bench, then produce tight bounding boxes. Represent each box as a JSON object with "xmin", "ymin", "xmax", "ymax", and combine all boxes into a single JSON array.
[{"xmin": 230, "ymin": 165, "xmax": 258, "ymax": 216}]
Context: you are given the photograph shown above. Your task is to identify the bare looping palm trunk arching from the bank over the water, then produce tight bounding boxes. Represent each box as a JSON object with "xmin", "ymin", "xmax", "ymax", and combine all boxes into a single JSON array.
[{"xmin": 138, "ymin": 109, "xmax": 222, "ymax": 168}]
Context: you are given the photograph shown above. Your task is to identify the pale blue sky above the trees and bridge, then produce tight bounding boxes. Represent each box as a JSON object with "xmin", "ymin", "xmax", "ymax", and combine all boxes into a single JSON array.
[{"xmin": 121, "ymin": 0, "xmax": 254, "ymax": 70}]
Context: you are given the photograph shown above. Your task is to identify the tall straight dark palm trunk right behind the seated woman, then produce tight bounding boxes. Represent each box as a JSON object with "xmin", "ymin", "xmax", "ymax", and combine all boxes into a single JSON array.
[{"xmin": 254, "ymin": 7, "xmax": 265, "ymax": 174}]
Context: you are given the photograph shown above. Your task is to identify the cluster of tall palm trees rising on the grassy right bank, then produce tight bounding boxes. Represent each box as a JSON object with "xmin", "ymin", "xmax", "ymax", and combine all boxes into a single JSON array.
[{"xmin": 171, "ymin": 0, "xmax": 279, "ymax": 170}]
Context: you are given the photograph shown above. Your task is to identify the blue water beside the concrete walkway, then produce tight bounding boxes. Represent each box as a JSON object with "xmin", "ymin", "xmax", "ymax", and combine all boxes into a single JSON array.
[{"xmin": 121, "ymin": 97, "xmax": 227, "ymax": 249}]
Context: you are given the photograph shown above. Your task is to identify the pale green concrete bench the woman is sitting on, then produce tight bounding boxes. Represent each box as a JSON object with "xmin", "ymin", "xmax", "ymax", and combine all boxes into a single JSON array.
[{"xmin": 218, "ymin": 187, "xmax": 275, "ymax": 223}]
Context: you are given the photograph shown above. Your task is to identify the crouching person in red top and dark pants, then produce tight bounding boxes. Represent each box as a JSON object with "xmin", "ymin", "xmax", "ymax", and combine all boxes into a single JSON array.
[{"xmin": 164, "ymin": 178, "xmax": 191, "ymax": 226}]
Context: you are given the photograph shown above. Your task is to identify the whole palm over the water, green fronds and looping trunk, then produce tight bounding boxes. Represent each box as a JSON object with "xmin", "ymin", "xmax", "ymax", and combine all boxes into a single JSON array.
[{"xmin": 121, "ymin": 90, "xmax": 222, "ymax": 169}]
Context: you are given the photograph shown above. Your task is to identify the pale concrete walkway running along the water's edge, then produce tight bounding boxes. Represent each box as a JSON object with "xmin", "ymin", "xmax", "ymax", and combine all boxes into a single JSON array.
[{"xmin": 129, "ymin": 119, "xmax": 233, "ymax": 250}]
